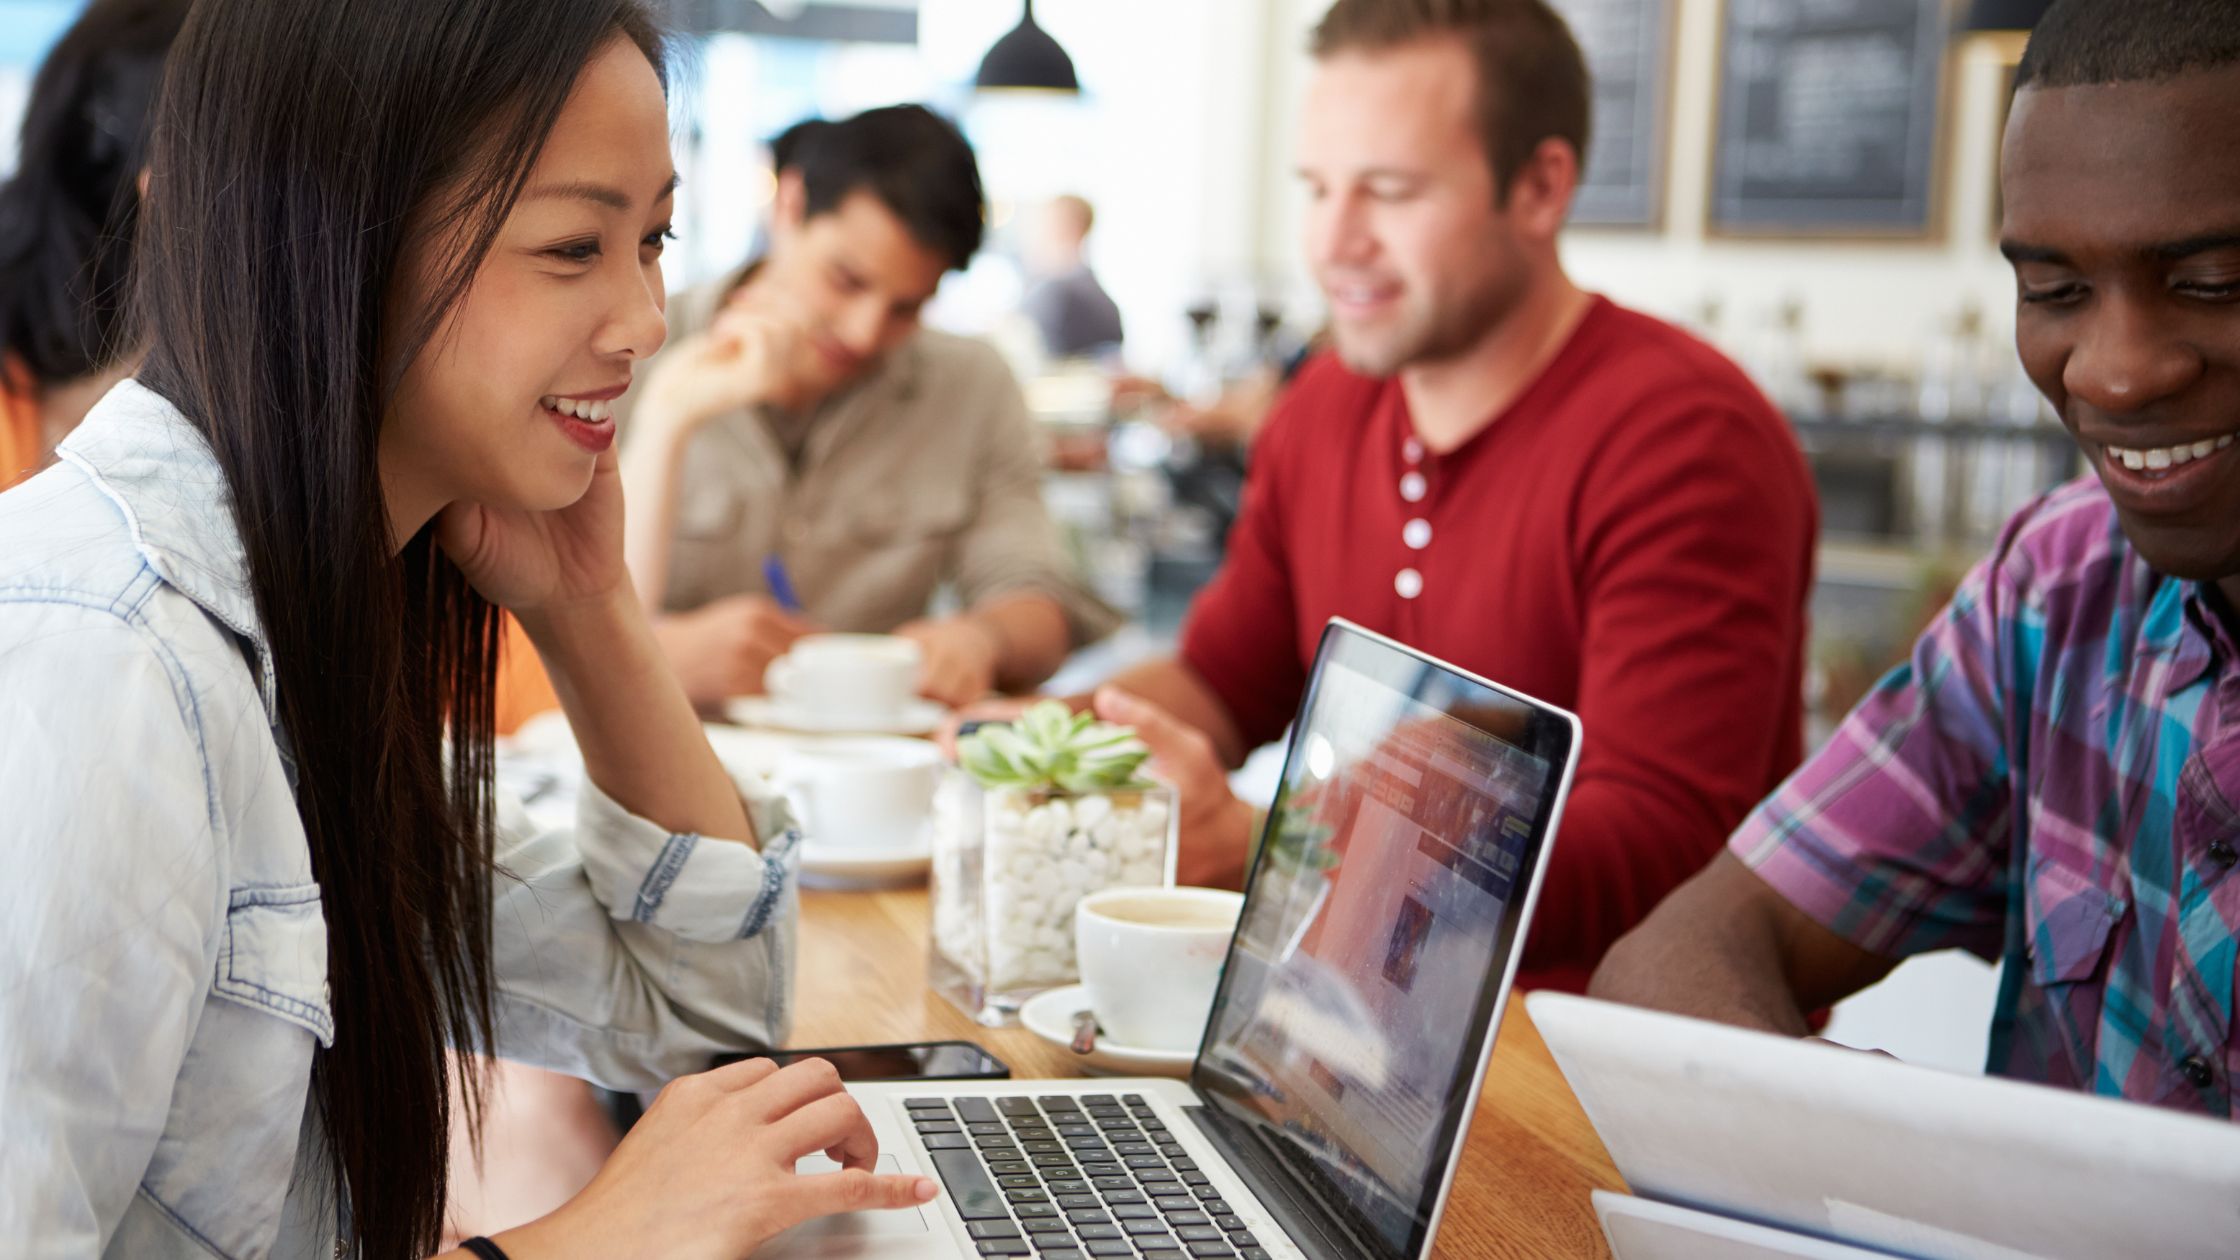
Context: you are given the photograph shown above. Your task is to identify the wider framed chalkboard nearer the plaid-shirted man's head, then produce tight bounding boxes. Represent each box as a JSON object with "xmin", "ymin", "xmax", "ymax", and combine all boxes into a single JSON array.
[{"xmin": 1711, "ymin": 0, "xmax": 1947, "ymax": 235}]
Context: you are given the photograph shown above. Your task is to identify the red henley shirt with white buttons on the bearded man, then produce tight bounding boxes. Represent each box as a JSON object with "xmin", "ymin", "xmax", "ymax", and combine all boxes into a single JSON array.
[{"xmin": 1183, "ymin": 298, "xmax": 1819, "ymax": 991}]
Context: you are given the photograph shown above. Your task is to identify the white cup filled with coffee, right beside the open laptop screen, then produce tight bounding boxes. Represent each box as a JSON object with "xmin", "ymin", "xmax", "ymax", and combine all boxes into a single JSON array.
[{"xmin": 1073, "ymin": 888, "xmax": 1245, "ymax": 1051}]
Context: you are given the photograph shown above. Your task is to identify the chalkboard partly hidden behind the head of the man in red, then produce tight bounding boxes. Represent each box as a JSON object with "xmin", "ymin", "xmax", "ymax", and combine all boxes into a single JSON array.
[{"xmin": 1555, "ymin": 0, "xmax": 1673, "ymax": 226}]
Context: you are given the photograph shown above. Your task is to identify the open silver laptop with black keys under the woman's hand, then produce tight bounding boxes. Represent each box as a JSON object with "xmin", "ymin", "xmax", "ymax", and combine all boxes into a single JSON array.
[{"xmin": 757, "ymin": 621, "xmax": 1579, "ymax": 1260}]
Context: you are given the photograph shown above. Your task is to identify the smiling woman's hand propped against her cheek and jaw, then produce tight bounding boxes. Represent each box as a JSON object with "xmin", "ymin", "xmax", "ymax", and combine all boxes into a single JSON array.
[{"xmin": 437, "ymin": 451, "xmax": 629, "ymax": 612}]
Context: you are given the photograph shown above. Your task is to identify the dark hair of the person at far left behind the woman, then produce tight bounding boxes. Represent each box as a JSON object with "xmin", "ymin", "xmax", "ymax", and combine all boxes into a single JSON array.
[{"xmin": 0, "ymin": 0, "xmax": 188, "ymax": 386}]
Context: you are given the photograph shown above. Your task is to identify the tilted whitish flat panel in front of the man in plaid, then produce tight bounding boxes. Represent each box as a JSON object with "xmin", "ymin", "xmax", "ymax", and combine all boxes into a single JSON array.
[{"xmin": 1525, "ymin": 993, "xmax": 2240, "ymax": 1260}]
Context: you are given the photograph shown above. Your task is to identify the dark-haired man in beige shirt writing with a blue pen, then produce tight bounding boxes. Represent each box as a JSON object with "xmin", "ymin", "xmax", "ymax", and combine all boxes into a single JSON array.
[{"xmin": 502, "ymin": 105, "xmax": 1118, "ymax": 713}]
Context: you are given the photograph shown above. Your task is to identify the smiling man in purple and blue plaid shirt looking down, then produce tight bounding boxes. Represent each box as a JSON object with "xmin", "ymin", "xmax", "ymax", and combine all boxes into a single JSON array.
[{"xmin": 1593, "ymin": 0, "xmax": 2240, "ymax": 1117}]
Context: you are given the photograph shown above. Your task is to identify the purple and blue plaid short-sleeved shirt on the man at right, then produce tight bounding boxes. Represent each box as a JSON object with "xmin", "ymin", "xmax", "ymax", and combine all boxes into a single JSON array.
[{"xmin": 1729, "ymin": 478, "xmax": 2240, "ymax": 1119}]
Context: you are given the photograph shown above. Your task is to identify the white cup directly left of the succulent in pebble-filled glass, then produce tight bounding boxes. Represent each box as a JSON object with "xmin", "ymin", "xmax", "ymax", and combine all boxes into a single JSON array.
[{"xmin": 777, "ymin": 740, "xmax": 945, "ymax": 850}]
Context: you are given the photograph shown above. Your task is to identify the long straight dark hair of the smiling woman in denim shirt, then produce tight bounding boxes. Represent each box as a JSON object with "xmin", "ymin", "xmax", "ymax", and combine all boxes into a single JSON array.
[{"xmin": 139, "ymin": 0, "xmax": 663, "ymax": 1258}]
